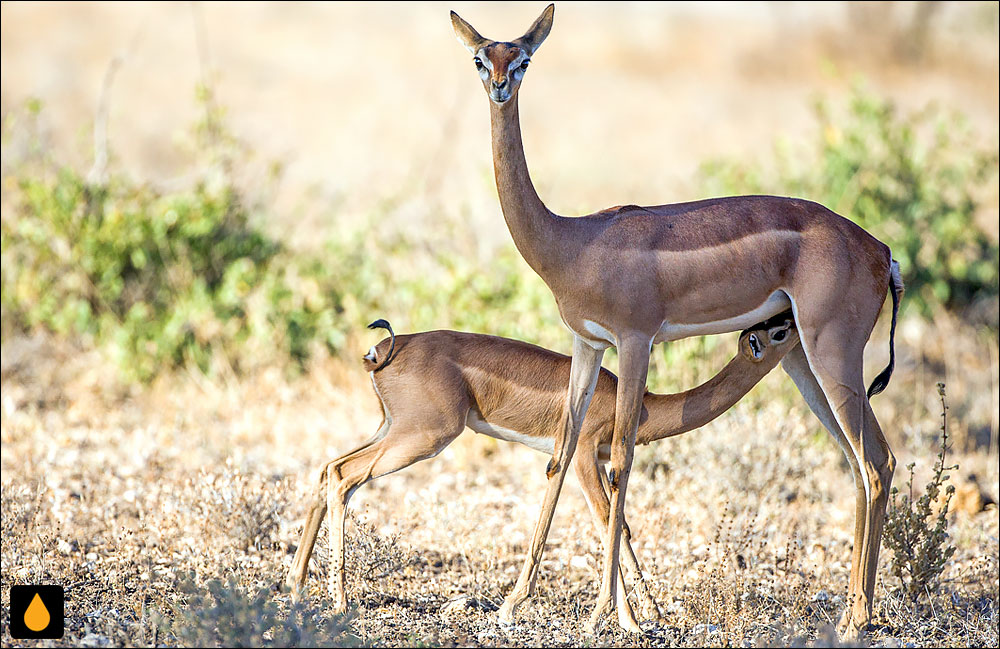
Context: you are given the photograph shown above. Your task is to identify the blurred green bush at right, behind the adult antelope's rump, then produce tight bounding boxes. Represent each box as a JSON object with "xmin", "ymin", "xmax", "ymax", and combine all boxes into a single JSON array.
[{"xmin": 702, "ymin": 90, "xmax": 1000, "ymax": 329}]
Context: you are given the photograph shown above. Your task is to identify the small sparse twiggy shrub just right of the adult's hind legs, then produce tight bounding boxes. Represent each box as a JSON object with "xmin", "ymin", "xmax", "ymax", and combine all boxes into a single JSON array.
[{"xmin": 885, "ymin": 383, "xmax": 958, "ymax": 602}]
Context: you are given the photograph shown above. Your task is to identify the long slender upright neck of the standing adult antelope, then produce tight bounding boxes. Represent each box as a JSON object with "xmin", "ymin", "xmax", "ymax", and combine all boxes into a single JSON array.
[{"xmin": 490, "ymin": 94, "xmax": 568, "ymax": 280}]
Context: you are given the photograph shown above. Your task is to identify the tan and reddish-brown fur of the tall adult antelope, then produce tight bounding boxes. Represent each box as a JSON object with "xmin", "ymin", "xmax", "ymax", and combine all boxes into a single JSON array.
[{"xmin": 452, "ymin": 5, "xmax": 897, "ymax": 636}]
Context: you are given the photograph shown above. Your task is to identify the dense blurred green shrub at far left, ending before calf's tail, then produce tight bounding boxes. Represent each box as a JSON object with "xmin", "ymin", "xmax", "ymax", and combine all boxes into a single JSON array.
[{"xmin": 2, "ymin": 161, "xmax": 356, "ymax": 380}]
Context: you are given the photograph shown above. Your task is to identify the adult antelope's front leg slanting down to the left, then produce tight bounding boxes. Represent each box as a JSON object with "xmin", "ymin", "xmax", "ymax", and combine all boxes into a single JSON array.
[{"xmin": 498, "ymin": 336, "xmax": 604, "ymax": 624}]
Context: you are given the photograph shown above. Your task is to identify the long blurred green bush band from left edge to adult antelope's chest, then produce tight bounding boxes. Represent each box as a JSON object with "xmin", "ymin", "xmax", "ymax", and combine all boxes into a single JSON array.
[{"xmin": 0, "ymin": 104, "xmax": 561, "ymax": 381}]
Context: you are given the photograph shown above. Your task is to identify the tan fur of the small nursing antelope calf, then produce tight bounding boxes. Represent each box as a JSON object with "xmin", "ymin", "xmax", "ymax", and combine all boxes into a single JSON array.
[{"xmin": 288, "ymin": 315, "xmax": 798, "ymax": 617}]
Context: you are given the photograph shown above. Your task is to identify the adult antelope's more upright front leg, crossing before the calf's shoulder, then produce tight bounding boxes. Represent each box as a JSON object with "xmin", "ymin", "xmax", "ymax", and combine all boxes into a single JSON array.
[{"xmin": 588, "ymin": 335, "xmax": 651, "ymax": 630}]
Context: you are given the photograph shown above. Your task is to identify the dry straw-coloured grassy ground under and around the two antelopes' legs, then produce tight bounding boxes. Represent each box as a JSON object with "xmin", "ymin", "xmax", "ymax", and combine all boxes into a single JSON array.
[{"xmin": 2, "ymin": 326, "xmax": 1000, "ymax": 646}]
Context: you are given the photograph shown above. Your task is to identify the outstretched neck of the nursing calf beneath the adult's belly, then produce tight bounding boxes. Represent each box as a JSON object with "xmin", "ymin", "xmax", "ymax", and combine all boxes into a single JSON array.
[{"xmin": 636, "ymin": 355, "xmax": 777, "ymax": 444}]
